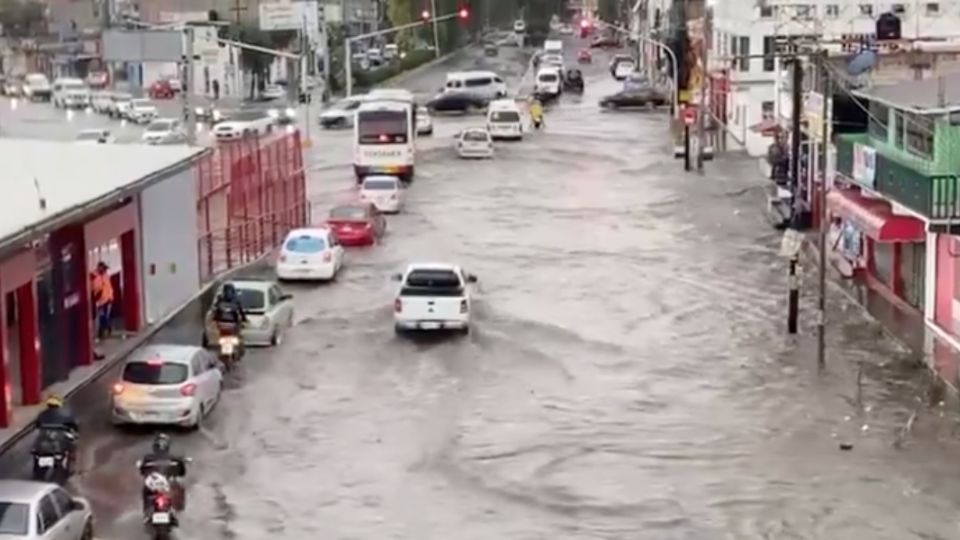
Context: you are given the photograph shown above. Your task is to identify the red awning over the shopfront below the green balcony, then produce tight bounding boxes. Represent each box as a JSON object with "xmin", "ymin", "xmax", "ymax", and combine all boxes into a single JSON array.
[{"xmin": 827, "ymin": 189, "xmax": 927, "ymax": 242}]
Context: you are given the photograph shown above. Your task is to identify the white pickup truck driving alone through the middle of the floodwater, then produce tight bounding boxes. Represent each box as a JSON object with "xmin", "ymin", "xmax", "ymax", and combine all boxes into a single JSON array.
[{"xmin": 393, "ymin": 263, "xmax": 477, "ymax": 334}]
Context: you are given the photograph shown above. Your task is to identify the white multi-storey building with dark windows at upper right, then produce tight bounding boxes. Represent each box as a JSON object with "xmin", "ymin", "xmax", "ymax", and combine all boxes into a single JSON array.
[{"xmin": 710, "ymin": 0, "xmax": 960, "ymax": 156}]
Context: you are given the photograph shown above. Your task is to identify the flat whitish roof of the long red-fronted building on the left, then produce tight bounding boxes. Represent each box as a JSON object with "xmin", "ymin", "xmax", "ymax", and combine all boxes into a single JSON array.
[{"xmin": 0, "ymin": 138, "xmax": 206, "ymax": 249}]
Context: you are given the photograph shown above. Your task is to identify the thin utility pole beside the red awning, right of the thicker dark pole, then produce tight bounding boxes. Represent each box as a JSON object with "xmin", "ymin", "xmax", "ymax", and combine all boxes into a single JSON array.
[{"xmin": 817, "ymin": 52, "xmax": 833, "ymax": 371}]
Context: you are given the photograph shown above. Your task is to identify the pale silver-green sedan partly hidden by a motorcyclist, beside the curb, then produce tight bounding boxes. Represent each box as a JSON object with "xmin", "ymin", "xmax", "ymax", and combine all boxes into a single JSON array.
[{"xmin": 203, "ymin": 279, "xmax": 294, "ymax": 346}]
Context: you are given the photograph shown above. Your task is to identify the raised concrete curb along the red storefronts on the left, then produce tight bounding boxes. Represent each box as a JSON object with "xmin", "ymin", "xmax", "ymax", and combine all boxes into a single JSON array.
[{"xmin": 0, "ymin": 250, "xmax": 275, "ymax": 454}]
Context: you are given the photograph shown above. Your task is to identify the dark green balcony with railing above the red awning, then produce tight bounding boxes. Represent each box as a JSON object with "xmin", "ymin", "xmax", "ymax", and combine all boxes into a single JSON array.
[{"xmin": 836, "ymin": 133, "xmax": 960, "ymax": 220}]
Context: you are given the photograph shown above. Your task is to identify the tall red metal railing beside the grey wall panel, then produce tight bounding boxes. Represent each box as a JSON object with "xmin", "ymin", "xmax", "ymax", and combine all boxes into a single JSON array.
[{"xmin": 197, "ymin": 131, "xmax": 309, "ymax": 282}]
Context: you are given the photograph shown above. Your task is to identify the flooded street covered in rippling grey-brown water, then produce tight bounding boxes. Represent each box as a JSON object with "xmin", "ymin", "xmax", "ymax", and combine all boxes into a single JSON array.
[{"xmin": 0, "ymin": 39, "xmax": 960, "ymax": 540}]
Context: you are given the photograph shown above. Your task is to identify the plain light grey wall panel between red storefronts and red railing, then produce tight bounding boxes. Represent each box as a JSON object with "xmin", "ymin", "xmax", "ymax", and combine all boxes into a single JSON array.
[{"xmin": 140, "ymin": 169, "xmax": 200, "ymax": 323}]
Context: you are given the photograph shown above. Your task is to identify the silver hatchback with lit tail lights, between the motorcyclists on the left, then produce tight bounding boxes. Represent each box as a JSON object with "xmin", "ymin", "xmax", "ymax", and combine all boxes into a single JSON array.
[{"xmin": 110, "ymin": 345, "xmax": 223, "ymax": 428}]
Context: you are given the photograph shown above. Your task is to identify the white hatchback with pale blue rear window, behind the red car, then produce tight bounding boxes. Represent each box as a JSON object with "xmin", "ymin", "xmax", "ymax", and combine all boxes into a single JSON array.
[{"xmin": 277, "ymin": 228, "xmax": 343, "ymax": 281}]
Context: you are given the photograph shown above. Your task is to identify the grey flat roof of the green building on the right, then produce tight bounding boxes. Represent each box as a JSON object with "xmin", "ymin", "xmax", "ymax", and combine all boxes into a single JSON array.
[{"xmin": 853, "ymin": 73, "xmax": 960, "ymax": 114}]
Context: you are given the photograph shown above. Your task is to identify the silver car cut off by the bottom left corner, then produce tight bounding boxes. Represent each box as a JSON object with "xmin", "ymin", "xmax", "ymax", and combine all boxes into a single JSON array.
[{"xmin": 0, "ymin": 480, "xmax": 94, "ymax": 540}]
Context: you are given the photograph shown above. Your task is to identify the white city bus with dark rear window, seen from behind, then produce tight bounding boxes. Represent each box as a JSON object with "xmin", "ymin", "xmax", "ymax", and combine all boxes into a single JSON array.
[{"xmin": 353, "ymin": 90, "xmax": 417, "ymax": 182}]
